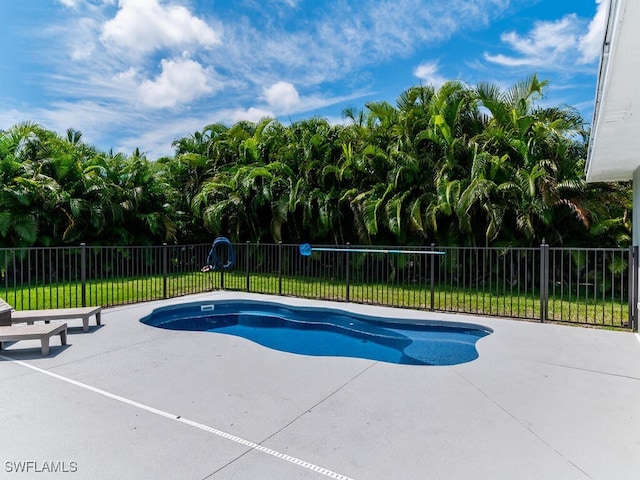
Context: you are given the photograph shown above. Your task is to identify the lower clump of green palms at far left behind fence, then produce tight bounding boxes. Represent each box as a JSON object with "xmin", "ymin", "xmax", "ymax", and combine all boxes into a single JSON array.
[{"xmin": 0, "ymin": 123, "xmax": 176, "ymax": 247}]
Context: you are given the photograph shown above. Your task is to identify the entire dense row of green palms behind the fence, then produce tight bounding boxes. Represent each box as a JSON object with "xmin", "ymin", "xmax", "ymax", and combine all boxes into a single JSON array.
[{"xmin": 0, "ymin": 76, "xmax": 631, "ymax": 247}]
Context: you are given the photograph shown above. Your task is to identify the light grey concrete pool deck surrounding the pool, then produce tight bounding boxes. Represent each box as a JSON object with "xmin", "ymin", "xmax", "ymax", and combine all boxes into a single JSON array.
[{"xmin": 0, "ymin": 292, "xmax": 640, "ymax": 480}]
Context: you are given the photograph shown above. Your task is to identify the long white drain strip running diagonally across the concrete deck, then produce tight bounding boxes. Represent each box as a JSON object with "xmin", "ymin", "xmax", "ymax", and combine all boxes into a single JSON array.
[{"xmin": 0, "ymin": 355, "xmax": 353, "ymax": 480}]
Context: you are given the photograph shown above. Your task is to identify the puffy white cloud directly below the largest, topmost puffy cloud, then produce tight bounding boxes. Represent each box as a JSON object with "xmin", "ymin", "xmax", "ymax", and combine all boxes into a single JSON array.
[{"xmin": 138, "ymin": 57, "xmax": 213, "ymax": 108}]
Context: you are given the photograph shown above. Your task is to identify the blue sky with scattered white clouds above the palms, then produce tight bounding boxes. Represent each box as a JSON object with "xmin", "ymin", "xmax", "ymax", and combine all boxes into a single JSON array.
[{"xmin": 0, "ymin": 0, "xmax": 608, "ymax": 159}]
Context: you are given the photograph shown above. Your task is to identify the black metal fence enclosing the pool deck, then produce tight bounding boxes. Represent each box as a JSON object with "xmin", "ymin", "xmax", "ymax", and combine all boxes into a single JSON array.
[{"xmin": 0, "ymin": 243, "xmax": 638, "ymax": 330}]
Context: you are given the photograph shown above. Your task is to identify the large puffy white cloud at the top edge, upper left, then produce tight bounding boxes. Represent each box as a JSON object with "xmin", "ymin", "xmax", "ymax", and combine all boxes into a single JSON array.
[{"xmin": 101, "ymin": 0, "xmax": 220, "ymax": 53}]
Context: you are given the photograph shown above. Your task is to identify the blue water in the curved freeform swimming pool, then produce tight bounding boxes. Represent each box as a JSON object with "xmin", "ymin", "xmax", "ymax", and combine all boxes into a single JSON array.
[{"xmin": 141, "ymin": 300, "xmax": 492, "ymax": 365}]
